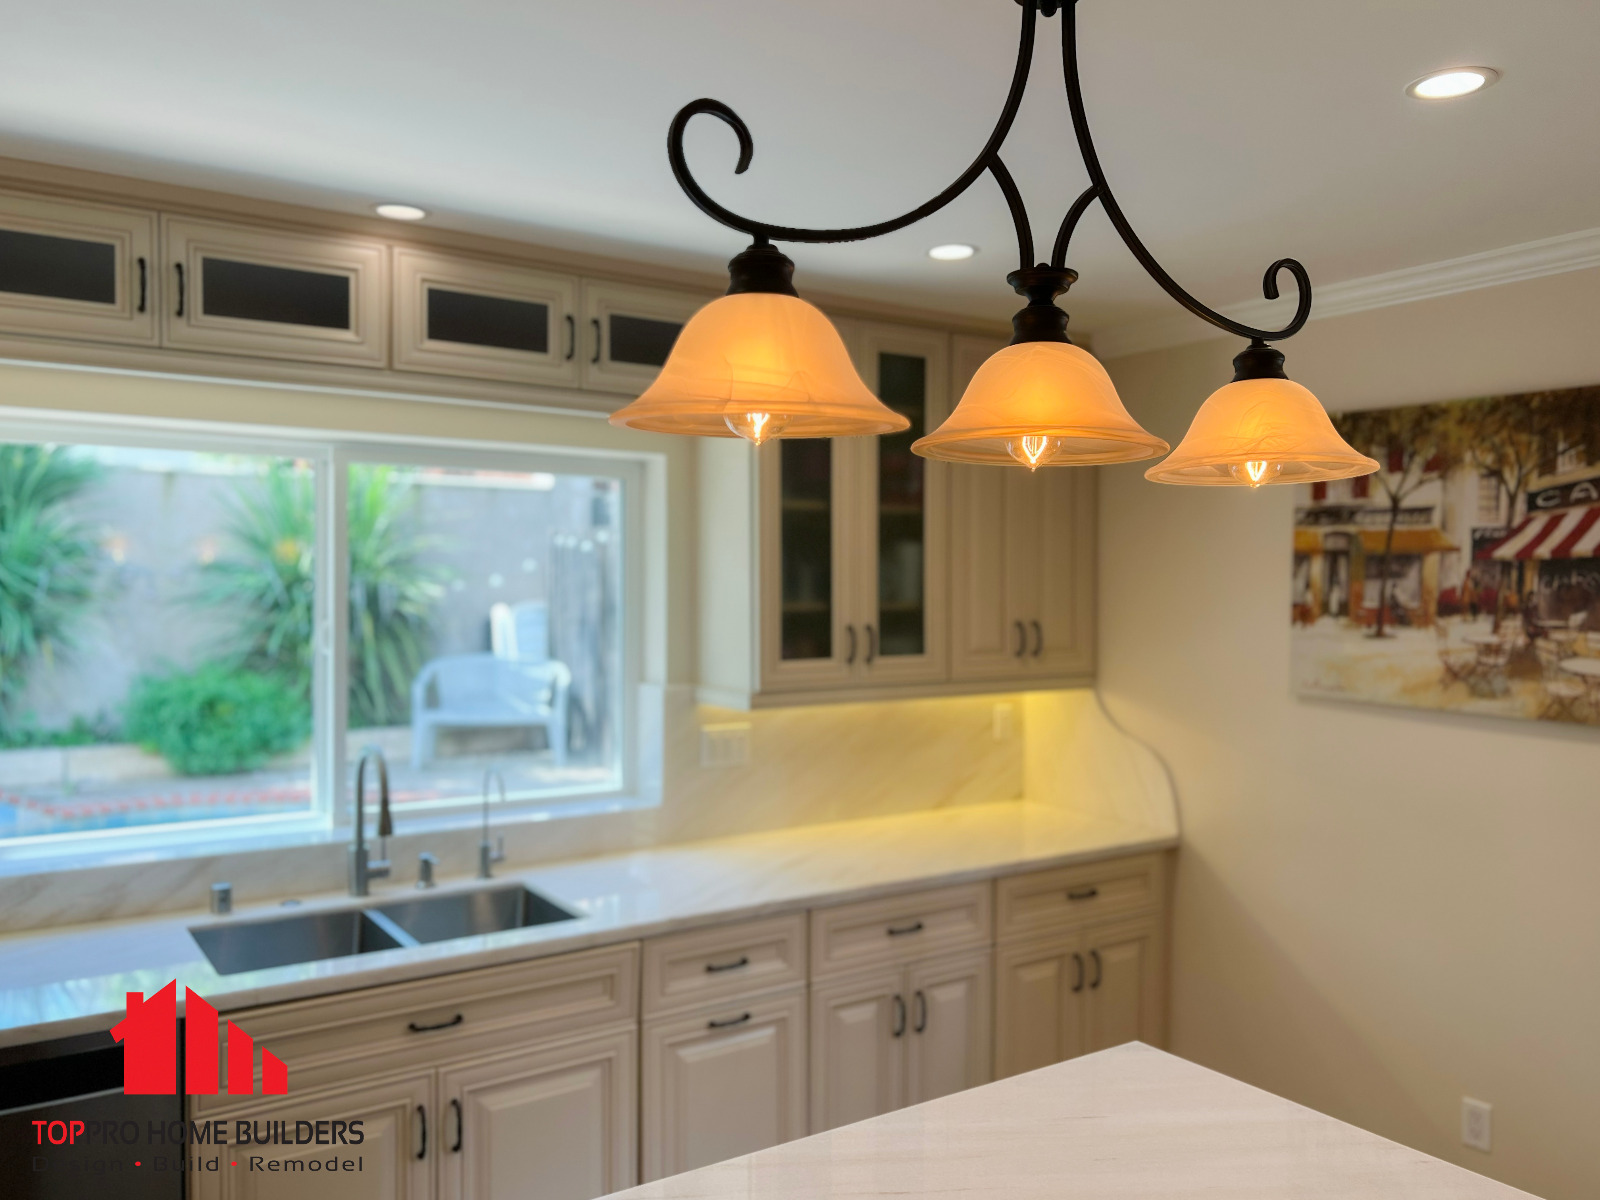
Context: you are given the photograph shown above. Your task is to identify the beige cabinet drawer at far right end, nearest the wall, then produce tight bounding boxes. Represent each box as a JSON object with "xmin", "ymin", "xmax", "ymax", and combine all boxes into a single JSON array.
[{"xmin": 995, "ymin": 854, "xmax": 1162, "ymax": 941}]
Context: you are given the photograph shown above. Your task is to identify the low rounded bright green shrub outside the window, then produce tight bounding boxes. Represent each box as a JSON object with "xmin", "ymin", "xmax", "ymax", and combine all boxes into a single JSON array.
[{"xmin": 125, "ymin": 662, "xmax": 310, "ymax": 774}]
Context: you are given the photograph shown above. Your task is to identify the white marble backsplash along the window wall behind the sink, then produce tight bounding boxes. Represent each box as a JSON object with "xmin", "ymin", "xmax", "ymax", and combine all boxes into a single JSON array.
[{"xmin": 0, "ymin": 686, "xmax": 1036, "ymax": 931}]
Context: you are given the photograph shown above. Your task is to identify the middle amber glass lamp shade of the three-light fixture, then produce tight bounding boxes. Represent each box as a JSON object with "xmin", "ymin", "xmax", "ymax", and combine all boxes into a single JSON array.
[{"xmin": 912, "ymin": 341, "xmax": 1170, "ymax": 467}]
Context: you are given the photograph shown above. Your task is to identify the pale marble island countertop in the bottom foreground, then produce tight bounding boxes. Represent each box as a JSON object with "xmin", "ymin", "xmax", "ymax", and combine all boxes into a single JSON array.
[{"xmin": 614, "ymin": 1042, "xmax": 1528, "ymax": 1200}]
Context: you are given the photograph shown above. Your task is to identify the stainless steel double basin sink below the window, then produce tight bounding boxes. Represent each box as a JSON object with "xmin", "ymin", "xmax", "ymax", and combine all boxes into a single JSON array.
[{"xmin": 189, "ymin": 883, "xmax": 578, "ymax": 974}]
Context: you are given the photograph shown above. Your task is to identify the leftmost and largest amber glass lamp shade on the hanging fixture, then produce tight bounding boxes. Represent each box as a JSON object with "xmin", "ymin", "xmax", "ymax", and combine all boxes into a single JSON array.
[{"xmin": 611, "ymin": 291, "xmax": 910, "ymax": 443}]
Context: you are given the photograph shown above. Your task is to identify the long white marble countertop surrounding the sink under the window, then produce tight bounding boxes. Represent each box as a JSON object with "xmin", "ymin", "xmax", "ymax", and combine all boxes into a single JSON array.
[{"xmin": 0, "ymin": 802, "xmax": 1178, "ymax": 1046}]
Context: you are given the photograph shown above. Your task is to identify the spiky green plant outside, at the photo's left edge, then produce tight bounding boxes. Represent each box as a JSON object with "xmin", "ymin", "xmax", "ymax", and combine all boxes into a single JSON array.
[{"xmin": 0, "ymin": 445, "xmax": 99, "ymax": 715}]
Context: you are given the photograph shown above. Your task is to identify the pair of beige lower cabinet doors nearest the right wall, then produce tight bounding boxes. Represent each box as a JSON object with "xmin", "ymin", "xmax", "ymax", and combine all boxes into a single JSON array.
[{"xmin": 995, "ymin": 915, "xmax": 1163, "ymax": 1078}]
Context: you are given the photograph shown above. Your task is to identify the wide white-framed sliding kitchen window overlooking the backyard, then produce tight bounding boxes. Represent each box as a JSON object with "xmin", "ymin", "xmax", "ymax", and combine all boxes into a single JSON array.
[{"xmin": 0, "ymin": 430, "xmax": 640, "ymax": 858}]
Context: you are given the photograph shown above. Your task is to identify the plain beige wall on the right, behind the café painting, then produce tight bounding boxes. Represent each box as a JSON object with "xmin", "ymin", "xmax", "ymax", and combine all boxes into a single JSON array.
[{"xmin": 1101, "ymin": 270, "xmax": 1600, "ymax": 1200}]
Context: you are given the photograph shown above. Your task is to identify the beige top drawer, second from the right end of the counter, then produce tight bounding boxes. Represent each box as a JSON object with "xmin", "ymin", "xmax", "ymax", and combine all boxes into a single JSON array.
[{"xmin": 811, "ymin": 883, "xmax": 990, "ymax": 976}]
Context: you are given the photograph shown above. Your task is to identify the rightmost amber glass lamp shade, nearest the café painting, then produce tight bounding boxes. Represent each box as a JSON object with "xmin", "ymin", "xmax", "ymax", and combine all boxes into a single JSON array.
[{"xmin": 1144, "ymin": 378, "xmax": 1378, "ymax": 488}]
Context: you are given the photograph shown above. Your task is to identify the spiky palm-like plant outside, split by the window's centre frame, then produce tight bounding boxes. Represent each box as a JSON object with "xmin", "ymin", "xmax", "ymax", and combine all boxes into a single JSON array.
[{"xmin": 200, "ymin": 466, "xmax": 445, "ymax": 728}]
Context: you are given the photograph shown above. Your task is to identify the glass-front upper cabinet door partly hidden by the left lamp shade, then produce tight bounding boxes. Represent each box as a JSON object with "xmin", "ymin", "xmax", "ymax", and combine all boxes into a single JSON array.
[{"xmin": 579, "ymin": 278, "xmax": 714, "ymax": 395}]
